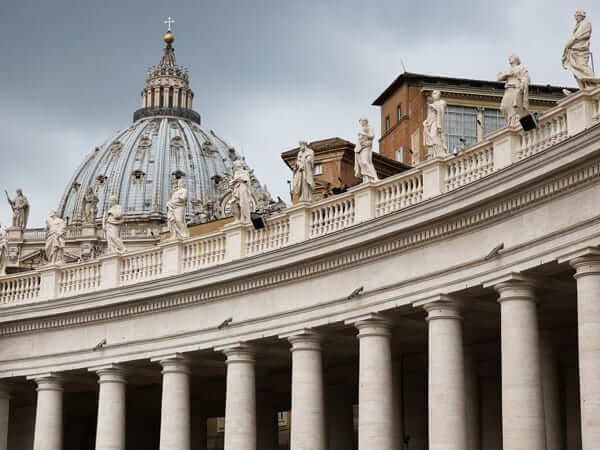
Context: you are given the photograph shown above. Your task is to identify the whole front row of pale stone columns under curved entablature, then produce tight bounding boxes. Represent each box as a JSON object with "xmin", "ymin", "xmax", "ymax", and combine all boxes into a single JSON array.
[{"xmin": 0, "ymin": 253, "xmax": 600, "ymax": 450}]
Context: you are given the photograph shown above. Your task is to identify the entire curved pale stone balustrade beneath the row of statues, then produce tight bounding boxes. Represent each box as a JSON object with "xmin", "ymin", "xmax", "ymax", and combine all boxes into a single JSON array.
[{"xmin": 0, "ymin": 89, "xmax": 600, "ymax": 306}]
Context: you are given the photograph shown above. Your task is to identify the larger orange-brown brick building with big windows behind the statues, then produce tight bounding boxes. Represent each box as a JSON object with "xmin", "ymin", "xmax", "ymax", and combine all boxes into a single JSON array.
[{"xmin": 373, "ymin": 72, "xmax": 565, "ymax": 165}]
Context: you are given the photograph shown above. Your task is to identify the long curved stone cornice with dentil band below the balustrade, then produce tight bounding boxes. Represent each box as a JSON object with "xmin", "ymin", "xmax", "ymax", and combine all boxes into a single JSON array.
[{"xmin": 0, "ymin": 127, "xmax": 600, "ymax": 336}]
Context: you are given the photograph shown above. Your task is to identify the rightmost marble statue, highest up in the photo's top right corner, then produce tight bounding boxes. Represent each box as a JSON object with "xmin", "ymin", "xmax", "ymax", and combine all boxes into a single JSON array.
[{"xmin": 562, "ymin": 11, "xmax": 600, "ymax": 89}]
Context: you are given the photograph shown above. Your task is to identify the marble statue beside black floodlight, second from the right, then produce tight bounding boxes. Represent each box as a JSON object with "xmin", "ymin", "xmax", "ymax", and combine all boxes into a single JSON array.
[{"xmin": 498, "ymin": 55, "xmax": 530, "ymax": 127}]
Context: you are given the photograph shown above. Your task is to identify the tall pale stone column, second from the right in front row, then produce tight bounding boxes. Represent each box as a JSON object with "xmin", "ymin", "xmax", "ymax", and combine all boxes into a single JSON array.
[{"xmin": 495, "ymin": 280, "xmax": 546, "ymax": 450}]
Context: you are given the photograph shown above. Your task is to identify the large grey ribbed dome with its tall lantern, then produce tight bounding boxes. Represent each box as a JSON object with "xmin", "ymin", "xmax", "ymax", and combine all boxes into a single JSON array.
[{"xmin": 59, "ymin": 26, "xmax": 271, "ymax": 224}]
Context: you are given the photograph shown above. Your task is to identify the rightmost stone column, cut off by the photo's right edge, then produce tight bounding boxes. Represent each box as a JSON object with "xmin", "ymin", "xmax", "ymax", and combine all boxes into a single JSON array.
[{"xmin": 571, "ymin": 252, "xmax": 600, "ymax": 450}]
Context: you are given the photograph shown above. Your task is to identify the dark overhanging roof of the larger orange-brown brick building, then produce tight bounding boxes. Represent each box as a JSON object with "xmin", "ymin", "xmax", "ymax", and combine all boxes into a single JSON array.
[{"xmin": 372, "ymin": 72, "xmax": 574, "ymax": 106}]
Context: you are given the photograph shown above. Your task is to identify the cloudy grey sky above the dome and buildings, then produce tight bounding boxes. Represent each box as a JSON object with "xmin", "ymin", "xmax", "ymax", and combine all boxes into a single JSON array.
[{"xmin": 0, "ymin": 0, "xmax": 600, "ymax": 226}]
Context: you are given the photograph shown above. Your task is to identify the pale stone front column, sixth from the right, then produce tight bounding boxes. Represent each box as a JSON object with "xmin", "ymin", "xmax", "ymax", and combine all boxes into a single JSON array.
[{"xmin": 220, "ymin": 344, "xmax": 256, "ymax": 450}]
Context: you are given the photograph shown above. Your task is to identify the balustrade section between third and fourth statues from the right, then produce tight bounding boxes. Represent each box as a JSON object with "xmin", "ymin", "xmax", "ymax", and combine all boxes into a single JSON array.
[{"xmin": 375, "ymin": 170, "xmax": 423, "ymax": 217}]
